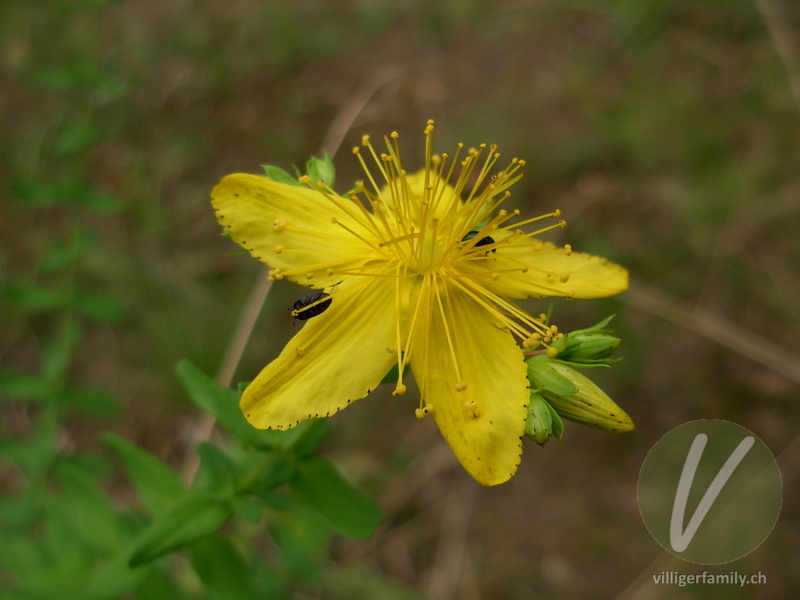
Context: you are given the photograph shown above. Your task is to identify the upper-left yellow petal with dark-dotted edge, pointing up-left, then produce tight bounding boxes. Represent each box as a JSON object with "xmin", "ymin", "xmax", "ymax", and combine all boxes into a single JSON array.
[{"xmin": 211, "ymin": 173, "xmax": 374, "ymax": 288}]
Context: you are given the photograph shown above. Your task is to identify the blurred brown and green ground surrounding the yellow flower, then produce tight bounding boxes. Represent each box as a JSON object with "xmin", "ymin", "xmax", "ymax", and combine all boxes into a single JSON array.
[{"xmin": 0, "ymin": 0, "xmax": 800, "ymax": 600}]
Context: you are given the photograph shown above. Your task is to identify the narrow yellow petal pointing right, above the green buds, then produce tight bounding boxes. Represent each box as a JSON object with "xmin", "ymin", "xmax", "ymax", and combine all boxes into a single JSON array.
[{"xmin": 467, "ymin": 240, "xmax": 628, "ymax": 298}]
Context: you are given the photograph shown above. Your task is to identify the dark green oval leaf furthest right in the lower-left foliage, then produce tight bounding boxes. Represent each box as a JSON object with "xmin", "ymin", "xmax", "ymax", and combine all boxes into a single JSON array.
[{"xmin": 289, "ymin": 456, "xmax": 385, "ymax": 538}]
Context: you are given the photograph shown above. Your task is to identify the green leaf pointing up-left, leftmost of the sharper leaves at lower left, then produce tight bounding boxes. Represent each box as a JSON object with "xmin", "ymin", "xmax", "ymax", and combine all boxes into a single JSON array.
[{"xmin": 103, "ymin": 433, "xmax": 185, "ymax": 515}]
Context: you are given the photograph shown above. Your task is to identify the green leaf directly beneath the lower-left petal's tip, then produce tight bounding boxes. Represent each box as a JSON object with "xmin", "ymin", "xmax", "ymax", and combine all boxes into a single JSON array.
[{"xmin": 177, "ymin": 361, "xmax": 280, "ymax": 449}]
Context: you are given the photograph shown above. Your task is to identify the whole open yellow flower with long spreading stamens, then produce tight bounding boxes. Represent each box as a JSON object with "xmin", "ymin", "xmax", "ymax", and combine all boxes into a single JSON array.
[{"xmin": 212, "ymin": 121, "xmax": 628, "ymax": 486}]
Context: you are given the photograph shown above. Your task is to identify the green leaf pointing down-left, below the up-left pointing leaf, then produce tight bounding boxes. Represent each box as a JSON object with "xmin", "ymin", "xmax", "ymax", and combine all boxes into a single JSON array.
[{"xmin": 129, "ymin": 490, "xmax": 233, "ymax": 567}]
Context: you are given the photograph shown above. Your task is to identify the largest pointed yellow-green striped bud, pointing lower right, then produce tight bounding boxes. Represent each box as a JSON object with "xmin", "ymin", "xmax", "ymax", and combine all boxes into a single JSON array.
[{"xmin": 539, "ymin": 360, "xmax": 634, "ymax": 433}]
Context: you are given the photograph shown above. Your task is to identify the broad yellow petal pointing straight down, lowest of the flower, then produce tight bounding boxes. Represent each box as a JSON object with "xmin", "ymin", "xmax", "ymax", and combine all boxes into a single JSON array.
[{"xmin": 411, "ymin": 287, "xmax": 530, "ymax": 486}]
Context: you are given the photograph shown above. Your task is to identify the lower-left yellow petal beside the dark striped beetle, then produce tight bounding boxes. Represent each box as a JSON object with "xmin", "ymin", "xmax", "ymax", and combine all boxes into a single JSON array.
[{"xmin": 240, "ymin": 277, "xmax": 396, "ymax": 429}]
